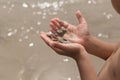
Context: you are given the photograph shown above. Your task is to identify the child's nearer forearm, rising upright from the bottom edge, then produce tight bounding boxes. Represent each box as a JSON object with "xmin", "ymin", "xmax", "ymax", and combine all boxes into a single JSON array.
[{"xmin": 76, "ymin": 53, "xmax": 98, "ymax": 80}]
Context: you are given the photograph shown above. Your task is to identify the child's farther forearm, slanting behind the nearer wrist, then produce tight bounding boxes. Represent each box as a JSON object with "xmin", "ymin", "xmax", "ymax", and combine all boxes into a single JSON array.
[{"xmin": 84, "ymin": 36, "xmax": 116, "ymax": 60}]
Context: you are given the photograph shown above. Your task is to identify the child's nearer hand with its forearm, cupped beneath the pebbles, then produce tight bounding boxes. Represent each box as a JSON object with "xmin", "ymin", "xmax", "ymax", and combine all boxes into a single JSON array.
[{"xmin": 40, "ymin": 32, "xmax": 98, "ymax": 80}]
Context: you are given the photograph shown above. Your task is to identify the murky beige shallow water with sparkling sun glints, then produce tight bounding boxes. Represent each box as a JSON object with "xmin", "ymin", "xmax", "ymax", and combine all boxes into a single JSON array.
[{"xmin": 0, "ymin": 0, "xmax": 120, "ymax": 80}]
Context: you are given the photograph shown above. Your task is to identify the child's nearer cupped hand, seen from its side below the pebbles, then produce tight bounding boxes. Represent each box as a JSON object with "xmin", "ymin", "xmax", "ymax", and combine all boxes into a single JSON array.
[{"xmin": 40, "ymin": 32, "xmax": 86, "ymax": 60}]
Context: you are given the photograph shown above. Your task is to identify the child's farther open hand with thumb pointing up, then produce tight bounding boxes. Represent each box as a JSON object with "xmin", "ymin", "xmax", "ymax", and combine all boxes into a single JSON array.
[{"xmin": 50, "ymin": 11, "xmax": 90, "ymax": 45}]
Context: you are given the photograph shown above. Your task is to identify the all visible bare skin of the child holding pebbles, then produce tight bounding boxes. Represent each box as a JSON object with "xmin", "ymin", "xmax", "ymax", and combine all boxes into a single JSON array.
[{"xmin": 40, "ymin": 0, "xmax": 120, "ymax": 80}]
